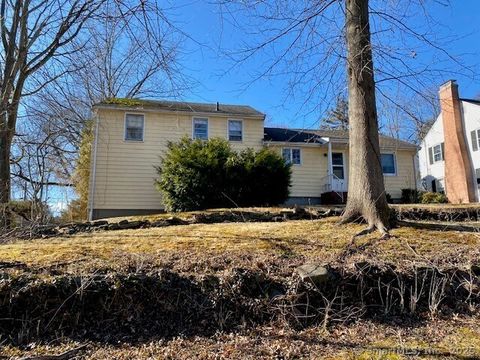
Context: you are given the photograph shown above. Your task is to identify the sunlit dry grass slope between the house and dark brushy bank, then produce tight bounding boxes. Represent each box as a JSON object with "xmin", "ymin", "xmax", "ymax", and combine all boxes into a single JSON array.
[{"xmin": 0, "ymin": 218, "xmax": 480, "ymax": 269}]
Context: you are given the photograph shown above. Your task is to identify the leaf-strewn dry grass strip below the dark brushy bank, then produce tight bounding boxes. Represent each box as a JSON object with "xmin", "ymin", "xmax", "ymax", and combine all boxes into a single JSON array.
[{"xmin": 0, "ymin": 319, "xmax": 480, "ymax": 360}]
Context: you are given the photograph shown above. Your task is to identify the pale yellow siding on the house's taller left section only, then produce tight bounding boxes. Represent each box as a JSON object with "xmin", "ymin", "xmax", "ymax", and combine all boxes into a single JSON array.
[{"xmin": 91, "ymin": 109, "xmax": 263, "ymax": 210}]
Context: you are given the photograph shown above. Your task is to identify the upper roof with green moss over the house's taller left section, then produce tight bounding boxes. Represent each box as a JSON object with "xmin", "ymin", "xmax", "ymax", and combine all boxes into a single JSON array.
[{"xmin": 94, "ymin": 98, "xmax": 265, "ymax": 118}]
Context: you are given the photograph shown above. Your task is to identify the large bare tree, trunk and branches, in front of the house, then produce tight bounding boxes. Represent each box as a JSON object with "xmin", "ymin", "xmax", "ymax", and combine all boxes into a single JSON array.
[{"xmin": 219, "ymin": 0, "xmax": 468, "ymax": 234}]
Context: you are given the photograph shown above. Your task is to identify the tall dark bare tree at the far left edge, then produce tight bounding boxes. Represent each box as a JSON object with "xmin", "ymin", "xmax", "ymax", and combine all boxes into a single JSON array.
[{"xmin": 0, "ymin": 0, "xmax": 103, "ymax": 218}]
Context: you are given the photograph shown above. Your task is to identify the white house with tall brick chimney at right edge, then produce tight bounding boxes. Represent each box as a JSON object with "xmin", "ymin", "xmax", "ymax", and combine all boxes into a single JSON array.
[{"xmin": 418, "ymin": 80, "xmax": 480, "ymax": 204}]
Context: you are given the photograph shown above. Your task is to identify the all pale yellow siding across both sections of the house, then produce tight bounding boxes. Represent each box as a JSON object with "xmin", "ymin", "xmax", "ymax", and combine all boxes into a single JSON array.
[{"xmin": 90, "ymin": 109, "xmax": 415, "ymax": 210}]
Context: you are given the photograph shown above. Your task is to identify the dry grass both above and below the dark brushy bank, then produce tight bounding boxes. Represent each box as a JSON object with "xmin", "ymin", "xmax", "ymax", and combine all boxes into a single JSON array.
[{"xmin": 0, "ymin": 215, "xmax": 480, "ymax": 360}]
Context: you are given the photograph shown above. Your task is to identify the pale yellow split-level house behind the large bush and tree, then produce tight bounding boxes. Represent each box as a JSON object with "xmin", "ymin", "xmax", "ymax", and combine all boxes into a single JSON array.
[{"xmin": 89, "ymin": 100, "xmax": 417, "ymax": 219}]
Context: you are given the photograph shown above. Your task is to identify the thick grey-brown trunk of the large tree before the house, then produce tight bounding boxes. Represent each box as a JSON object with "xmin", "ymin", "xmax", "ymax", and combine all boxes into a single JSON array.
[{"xmin": 343, "ymin": 0, "xmax": 389, "ymax": 233}]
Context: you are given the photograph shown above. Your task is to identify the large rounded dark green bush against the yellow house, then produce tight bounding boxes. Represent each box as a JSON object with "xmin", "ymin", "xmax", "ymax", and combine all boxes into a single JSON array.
[{"xmin": 156, "ymin": 138, "xmax": 291, "ymax": 211}]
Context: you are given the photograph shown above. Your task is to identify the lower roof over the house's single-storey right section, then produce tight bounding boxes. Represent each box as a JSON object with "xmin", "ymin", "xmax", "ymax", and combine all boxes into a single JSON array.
[{"xmin": 264, "ymin": 128, "xmax": 417, "ymax": 150}]
